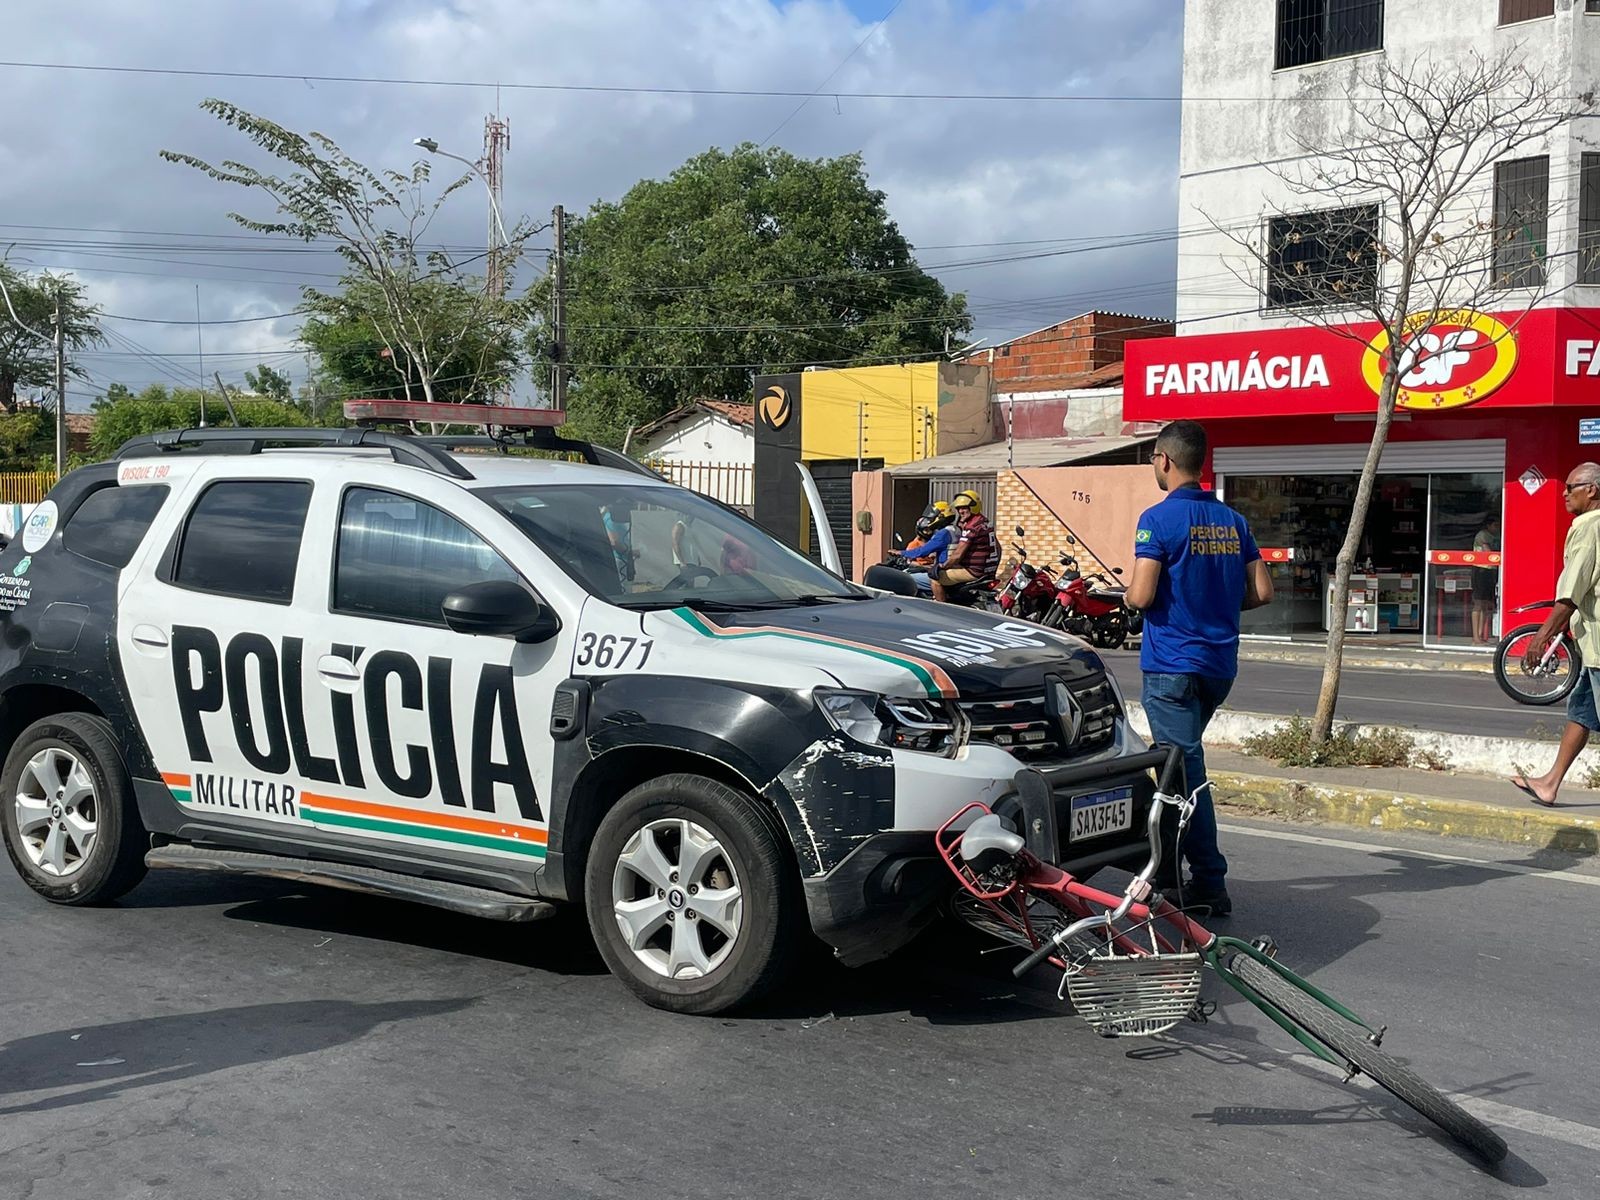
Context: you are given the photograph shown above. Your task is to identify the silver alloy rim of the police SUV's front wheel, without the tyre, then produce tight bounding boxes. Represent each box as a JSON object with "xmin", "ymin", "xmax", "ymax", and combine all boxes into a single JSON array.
[{"xmin": 611, "ymin": 818, "xmax": 744, "ymax": 981}]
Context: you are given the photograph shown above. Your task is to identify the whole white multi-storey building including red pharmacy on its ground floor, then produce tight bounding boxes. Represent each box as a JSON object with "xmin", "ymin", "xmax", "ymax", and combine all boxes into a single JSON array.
[{"xmin": 1125, "ymin": 0, "xmax": 1600, "ymax": 646}]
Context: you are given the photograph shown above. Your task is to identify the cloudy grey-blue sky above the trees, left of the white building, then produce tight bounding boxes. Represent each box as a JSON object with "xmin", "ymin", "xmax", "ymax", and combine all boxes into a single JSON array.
[{"xmin": 0, "ymin": 0, "xmax": 1182, "ymax": 408}]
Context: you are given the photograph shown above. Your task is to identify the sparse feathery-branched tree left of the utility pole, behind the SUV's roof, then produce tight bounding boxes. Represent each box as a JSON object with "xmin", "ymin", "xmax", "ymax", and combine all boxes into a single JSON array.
[{"xmin": 162, "ymin": 99, "xmax": 533, "ymax": 402}]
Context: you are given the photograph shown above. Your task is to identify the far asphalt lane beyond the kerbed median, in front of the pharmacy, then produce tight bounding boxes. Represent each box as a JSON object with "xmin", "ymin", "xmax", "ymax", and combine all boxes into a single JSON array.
[{"xmin": 1106, "ymin": 651, "xmax": 1566, "ymax": 739}]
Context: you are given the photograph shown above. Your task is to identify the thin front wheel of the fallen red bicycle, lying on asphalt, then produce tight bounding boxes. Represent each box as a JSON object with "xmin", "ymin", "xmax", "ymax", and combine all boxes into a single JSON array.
[{"xmin": 1229, "ymin": 954, "xmax": 1506, "ymax": 1166}]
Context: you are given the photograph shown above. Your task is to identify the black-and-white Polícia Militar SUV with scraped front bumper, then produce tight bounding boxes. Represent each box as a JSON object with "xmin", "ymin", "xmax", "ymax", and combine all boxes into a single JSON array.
[{"xmin": 0, "ymin": 429, "xmax": 1150, "ymax": 1013}]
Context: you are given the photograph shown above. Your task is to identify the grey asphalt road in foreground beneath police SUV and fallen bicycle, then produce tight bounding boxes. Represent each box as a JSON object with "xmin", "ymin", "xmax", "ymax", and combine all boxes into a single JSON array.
[{"xmin": 0, "ymin": 824, "xmax": 1600, "ymax": 1200}]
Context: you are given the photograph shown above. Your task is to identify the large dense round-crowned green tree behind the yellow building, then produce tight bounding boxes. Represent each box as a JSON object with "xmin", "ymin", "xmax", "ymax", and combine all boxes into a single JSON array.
[{"xmin": 530, "ymin": 144, "xmax": 973, "ymax": 445}]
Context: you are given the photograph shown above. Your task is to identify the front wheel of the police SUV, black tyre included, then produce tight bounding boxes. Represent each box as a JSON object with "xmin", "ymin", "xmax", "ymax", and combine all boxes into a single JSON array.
[{"xmin": 584, "ymin": 774, "xmax": 803, "ymax": 1014}]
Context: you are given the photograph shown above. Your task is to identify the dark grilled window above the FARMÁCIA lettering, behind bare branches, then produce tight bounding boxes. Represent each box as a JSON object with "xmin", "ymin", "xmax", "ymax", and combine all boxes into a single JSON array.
[{"xmin": 1267, "ymin": 205, "xmax": 1378, "ymax": 309}]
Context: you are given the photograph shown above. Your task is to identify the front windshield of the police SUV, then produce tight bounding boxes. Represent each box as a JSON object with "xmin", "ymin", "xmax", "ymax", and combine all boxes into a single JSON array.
[{"xmin": 478, "ymin": 483, "xmax": 867, "ymax": 610}]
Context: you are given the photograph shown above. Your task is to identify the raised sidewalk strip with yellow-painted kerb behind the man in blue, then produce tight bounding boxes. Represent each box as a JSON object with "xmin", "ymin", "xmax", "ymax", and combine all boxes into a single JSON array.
[{"xmin": 1206, "ymin": 747, "xmax": 1600, "ymax": 854}]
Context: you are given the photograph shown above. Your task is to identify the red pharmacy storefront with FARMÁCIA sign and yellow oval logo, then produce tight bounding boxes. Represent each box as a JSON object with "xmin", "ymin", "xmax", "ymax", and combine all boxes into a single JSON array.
[{"xmin": 1123, "ymin": 309, "xmax": 1600, "ymax": 648}]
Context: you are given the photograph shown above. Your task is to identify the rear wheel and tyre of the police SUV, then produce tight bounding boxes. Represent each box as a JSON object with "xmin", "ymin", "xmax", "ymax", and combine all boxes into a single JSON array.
[{"xmin": 0, "ymin": 712, "xmax": 149, "ymax": 906}]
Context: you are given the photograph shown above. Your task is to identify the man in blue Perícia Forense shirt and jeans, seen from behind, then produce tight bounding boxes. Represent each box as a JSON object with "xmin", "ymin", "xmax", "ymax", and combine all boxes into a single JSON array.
[{"xmin": 1126, "ymin": 421, "xmax": 1272, "ymax": 917}]
